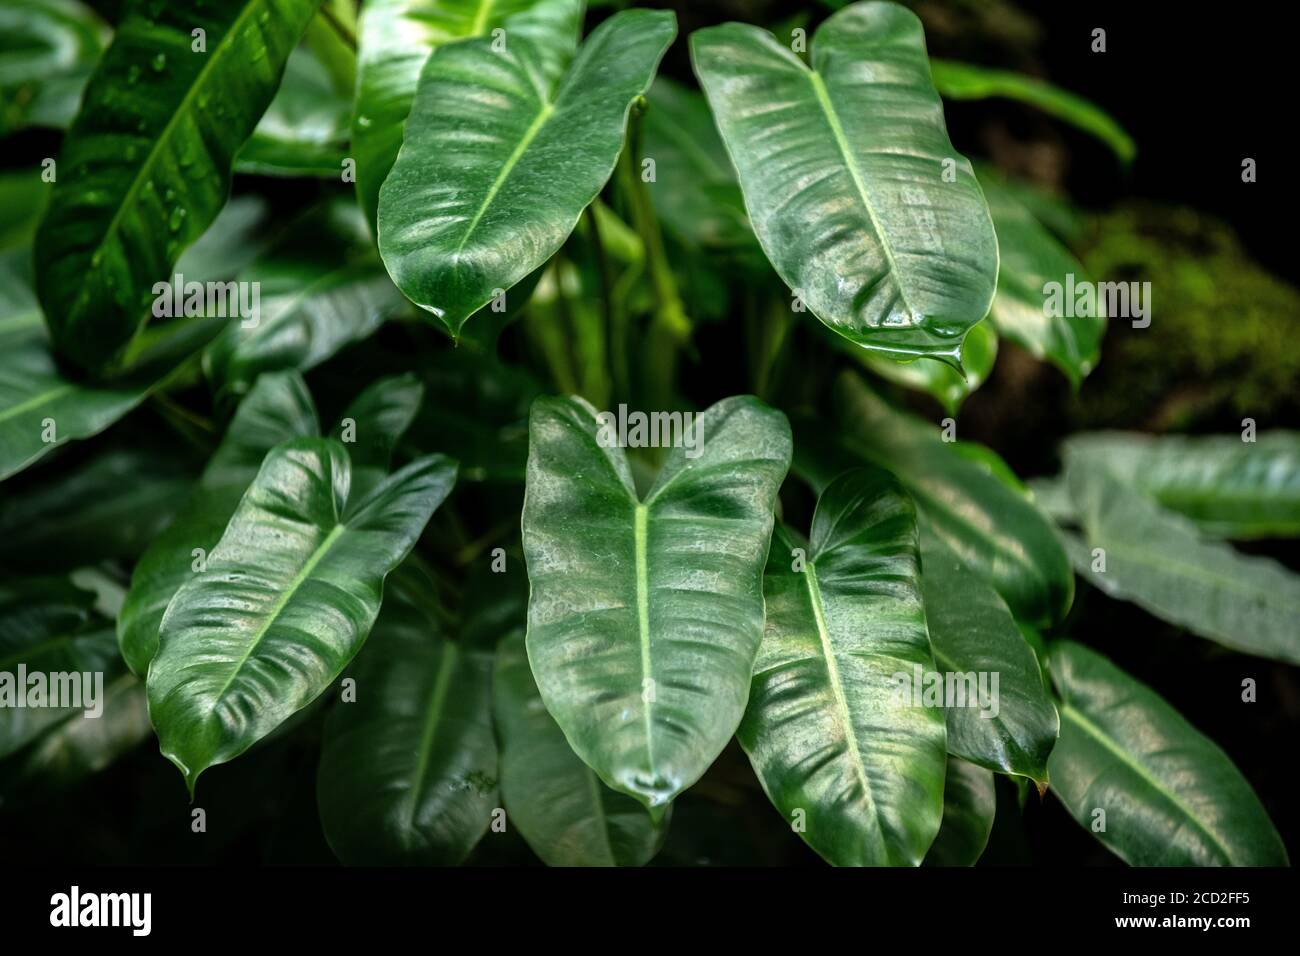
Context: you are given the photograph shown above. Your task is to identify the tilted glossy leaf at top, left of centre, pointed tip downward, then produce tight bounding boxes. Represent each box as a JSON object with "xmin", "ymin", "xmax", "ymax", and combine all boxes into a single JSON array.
[{"xmin": 380, "ymin": 10, "xmax": 676, "ymax": 337}]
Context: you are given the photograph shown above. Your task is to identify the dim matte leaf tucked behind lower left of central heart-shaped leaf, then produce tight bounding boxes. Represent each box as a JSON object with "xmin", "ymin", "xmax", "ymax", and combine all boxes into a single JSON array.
[{"xmin": 494, "ymin": 630, "xmax": 667, "ymax": 866}]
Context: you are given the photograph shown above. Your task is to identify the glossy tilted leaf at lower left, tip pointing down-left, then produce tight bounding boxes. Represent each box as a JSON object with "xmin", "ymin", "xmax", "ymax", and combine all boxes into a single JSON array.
[{"xmin": 148, "ymin": 438, "xmax": 455, "ymax": 792}]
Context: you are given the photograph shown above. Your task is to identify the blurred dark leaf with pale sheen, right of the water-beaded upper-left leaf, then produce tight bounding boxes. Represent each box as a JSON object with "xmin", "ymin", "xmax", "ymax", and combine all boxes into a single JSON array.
[{"xmin": 203, "ymin": 202, "xmax": 403, "ymax": 398}]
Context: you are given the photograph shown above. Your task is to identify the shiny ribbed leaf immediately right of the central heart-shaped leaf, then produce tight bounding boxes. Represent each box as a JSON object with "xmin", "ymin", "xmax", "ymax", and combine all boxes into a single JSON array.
[{"xmin": 736, "ymin": 468, "xmax": 948, "ymax": 866}]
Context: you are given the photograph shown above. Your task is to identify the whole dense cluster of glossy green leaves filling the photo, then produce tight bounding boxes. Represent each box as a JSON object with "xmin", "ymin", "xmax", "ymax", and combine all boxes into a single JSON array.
[{"xmin": 0, "ymin": 0, "xmax": 1300, "ymax": 865}]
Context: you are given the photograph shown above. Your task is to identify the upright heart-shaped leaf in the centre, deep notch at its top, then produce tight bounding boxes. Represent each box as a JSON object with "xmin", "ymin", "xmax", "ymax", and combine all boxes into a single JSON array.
[{"xmin": 523, "ymin": 397, "xmax": 790, "ymax": 814}]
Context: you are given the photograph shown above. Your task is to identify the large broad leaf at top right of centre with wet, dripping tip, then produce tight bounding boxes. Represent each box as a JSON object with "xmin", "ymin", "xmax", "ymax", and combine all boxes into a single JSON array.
[{"xmin": 690, "ymin": 3, "xmax": 997, "ymax": 365}]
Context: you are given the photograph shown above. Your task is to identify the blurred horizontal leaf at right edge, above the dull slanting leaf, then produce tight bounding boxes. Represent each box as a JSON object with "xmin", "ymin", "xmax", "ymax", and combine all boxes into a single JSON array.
[{"xmin": 1069, "ymin": 432, "xmax": 1300, "ymax": 538}]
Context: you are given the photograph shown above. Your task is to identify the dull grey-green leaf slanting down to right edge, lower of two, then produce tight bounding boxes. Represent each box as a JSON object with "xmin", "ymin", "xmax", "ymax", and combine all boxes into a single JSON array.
[{"xmin": 1066, "ymin": 450, "xmax": 1300, "ymax": 663}]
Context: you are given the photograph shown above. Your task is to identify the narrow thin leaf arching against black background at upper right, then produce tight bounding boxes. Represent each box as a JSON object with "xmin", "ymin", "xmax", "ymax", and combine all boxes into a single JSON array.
[{"xmin": 930, "ymin": 59, "xmax": 1138, "ymax": 164}]
